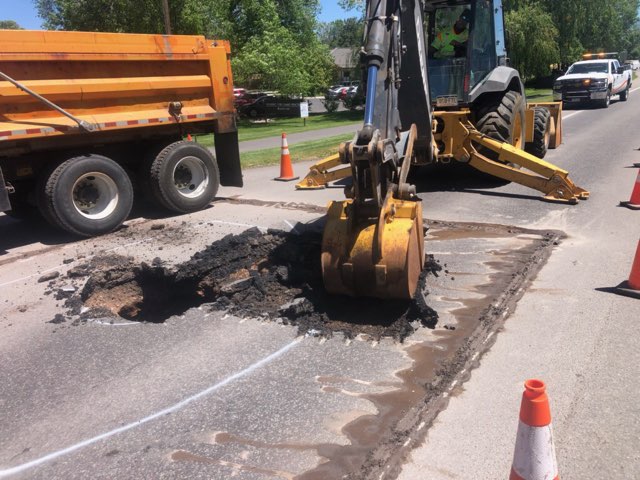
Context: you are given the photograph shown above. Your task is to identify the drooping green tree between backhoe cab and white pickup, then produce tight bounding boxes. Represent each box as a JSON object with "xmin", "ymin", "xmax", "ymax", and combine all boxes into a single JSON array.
[{"xmin": 505, "ymin": 2, "xmax": 560, "ymax": 80}]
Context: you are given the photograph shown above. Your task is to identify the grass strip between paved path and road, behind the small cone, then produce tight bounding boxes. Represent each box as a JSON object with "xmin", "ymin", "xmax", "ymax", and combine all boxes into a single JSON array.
[{"xmin": 240, "ymin": 134, "xmax": 353, "ymax": 168}]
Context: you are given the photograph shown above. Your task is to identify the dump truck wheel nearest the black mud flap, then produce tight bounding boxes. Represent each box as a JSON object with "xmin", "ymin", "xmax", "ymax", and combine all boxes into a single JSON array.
[{"xmin": 150, "ymin": 141, "xmax": 220, "ymax": 213}]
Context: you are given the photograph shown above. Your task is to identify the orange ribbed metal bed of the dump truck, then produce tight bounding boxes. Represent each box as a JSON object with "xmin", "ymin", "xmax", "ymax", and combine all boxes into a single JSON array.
[{"xmin": 0, "ymin": 30, "xmax": 236, "ymax": 148}]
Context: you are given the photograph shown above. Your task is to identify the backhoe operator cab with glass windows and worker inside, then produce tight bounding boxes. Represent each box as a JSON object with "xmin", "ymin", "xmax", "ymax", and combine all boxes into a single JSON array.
[{"xmin": 425, "ymin": 0, "xmax": 510, "ymax": 107}]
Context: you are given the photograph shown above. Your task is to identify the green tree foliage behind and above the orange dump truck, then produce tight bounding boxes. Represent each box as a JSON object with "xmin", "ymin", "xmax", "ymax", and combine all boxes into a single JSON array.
[{"xmin": 35, "ymin": 0, "xmax": 333, "ymax": 94}]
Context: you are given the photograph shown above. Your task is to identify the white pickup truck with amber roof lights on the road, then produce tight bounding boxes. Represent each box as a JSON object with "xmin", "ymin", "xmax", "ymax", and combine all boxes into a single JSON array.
[{"xmin": 553, "ymin": 58, "xmax": 632, "ymax": 108}]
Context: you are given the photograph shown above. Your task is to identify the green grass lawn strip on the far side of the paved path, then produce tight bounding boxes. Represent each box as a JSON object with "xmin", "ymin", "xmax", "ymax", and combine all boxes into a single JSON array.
[{"xmin": 198, "ymin": 110, "xmax": 363, "ymax": 147}]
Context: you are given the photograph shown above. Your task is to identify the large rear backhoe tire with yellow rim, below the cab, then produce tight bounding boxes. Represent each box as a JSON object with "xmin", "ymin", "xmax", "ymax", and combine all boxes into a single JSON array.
[{"xmin": 476, "ymin": 90, "xmax": 525, "ymax": 151}]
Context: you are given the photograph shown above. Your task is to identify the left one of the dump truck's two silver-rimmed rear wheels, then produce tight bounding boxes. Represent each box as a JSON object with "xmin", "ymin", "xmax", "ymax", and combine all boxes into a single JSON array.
[{"xmin": 38, "ymin": 155, "xmax": 133, "ymax": 237}]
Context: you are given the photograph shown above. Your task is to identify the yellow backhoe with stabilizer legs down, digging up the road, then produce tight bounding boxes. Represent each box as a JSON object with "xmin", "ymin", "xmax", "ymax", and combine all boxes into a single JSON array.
[{"xmin": 296, "ymin": 0, "xmax": 589, "ymax": 299}]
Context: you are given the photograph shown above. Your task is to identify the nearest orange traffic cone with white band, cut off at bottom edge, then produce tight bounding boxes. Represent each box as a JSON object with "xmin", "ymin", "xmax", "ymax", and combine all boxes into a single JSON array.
[{"xmin": 509, "ymin": 379, "xmax": 560, "ymax": 480}]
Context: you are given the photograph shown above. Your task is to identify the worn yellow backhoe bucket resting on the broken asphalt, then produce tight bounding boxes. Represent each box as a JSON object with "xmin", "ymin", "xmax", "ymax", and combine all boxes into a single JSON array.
[{"xmin": 321, "ymin": 197, "xmax": 424, "ymax": 300}]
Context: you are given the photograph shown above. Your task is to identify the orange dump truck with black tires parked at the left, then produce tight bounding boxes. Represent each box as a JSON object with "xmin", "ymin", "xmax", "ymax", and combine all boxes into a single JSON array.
[{"xmin": 0, "ymin": 30, "xmax": 242, "ymax": 236}]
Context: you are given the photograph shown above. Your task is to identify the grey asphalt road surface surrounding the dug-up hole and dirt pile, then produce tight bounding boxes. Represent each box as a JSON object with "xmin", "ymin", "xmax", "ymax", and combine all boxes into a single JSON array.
[{"xmin": 0, "ymin": 93, "xmax": 640, "ymax": 479}]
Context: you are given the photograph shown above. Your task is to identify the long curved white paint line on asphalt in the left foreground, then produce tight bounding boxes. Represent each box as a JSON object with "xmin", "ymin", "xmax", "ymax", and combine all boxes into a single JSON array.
[{"xmin": 0, "ymin": 337, "xmax": 303, "ymax": 478}]
